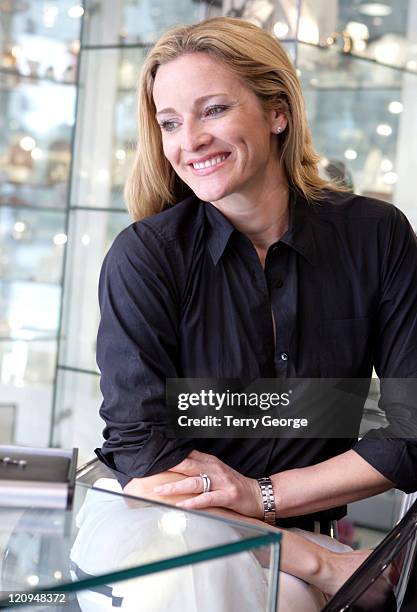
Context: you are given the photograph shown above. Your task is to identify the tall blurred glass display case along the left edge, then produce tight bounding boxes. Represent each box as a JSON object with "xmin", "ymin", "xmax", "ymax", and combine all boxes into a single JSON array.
[{"xmin": 0, "ymin": 0, "xmax": 82, "ymax": 445}]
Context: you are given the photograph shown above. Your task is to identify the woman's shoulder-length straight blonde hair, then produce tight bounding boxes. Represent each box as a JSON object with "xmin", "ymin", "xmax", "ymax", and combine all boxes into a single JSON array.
[{"xmin": 125, "ymin": 17, "xmax": 343, "ymax": 220}]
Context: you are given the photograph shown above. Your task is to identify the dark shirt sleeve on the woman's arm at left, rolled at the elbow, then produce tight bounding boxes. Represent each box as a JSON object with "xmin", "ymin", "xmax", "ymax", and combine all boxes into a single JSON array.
[{"xmin": 96, "ymin": 222, "xmax": 192, "ymax": 486}]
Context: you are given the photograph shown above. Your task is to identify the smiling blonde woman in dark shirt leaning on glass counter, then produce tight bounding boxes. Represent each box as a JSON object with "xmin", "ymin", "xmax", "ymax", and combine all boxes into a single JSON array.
[{"xmin": 97, "ymin": 18, "xmax": 417, "ymax": 604}]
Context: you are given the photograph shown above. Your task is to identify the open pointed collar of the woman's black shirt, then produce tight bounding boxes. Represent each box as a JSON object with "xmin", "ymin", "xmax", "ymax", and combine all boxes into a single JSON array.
[{"xmin": 203, "ymin": 189, "xmax": 317, "ymax": 265}]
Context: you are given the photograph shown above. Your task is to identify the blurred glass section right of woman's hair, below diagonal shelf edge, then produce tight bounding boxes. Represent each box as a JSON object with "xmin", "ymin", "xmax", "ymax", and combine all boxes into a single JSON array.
[{"xmin": 298, "ymin": 44, "xmax": 408, "ymax": 201}]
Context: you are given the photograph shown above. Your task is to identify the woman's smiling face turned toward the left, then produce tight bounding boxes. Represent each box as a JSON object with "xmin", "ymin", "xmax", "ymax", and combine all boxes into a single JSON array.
[{"xmin": 153, "ymin": 53, "xmax": 286, "ymax": 203}]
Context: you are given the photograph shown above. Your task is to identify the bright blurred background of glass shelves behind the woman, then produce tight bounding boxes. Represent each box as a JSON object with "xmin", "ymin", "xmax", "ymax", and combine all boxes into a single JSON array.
[{"xmin": 0, "ymin": 0, "xmax": 417, "ymax": 545}]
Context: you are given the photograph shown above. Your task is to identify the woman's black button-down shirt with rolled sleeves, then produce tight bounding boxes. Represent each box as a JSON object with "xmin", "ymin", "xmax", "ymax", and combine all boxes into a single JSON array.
[{"xmin": 96, "ymin": 192, "xmax": 417, "ymax": 518}]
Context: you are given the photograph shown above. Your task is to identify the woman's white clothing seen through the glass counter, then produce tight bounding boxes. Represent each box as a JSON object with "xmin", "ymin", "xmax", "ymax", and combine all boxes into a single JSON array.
[{"xmin": 71, "ymin": 486, "xmax": 270, "ymax": 612}]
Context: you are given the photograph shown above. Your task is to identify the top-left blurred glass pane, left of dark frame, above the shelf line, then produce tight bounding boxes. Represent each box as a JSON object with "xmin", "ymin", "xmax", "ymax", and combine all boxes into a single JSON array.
[{"xmin": 0, "ymin": 0, "xmax": 81, "ymax": 208}]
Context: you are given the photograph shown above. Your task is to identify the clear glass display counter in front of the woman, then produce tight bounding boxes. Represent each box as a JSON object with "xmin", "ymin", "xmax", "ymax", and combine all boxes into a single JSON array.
[{"xmin": 0, "ymin": 478, "xmax": 281, "ymax": 612}]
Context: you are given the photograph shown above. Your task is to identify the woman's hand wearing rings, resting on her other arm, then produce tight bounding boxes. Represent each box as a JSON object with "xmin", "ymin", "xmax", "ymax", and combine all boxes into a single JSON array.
[{"xmin": 154, "ymin": 450, "xmax": 264, "ymax": 519}]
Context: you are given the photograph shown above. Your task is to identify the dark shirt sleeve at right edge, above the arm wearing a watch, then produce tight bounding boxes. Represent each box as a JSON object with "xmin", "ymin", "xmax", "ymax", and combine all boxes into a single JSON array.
[{"xmin": 354, "ymin": 207, "xmax": 417, "ymax": 493}]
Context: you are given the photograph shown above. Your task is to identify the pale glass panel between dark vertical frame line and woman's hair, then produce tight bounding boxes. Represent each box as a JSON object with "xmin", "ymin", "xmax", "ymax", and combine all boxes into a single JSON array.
[{"xmin": 71, "ymin": 48, "xmax": 145, "ymax": 209}]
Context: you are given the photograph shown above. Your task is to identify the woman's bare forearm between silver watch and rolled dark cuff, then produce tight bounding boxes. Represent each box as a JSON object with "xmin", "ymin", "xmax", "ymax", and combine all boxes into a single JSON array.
[{"xmin": 271, "ymin": 450, "xmax": 394, "ymax": 518}]
